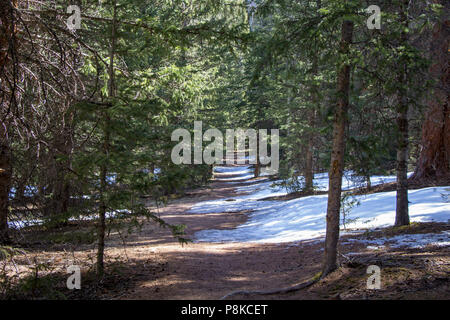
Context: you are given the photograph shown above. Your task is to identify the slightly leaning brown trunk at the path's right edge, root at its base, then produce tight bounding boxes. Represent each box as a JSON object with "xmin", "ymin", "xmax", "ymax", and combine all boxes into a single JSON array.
[{"xmin": 322, "ymin": 21, "xmax": 354, "ymax": 277}]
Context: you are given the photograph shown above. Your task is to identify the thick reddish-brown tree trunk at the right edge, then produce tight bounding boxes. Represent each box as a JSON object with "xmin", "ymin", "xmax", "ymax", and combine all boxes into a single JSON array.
[{"xmin": 411, "ymin": 0, "xmax": 450, "ymax": 184}]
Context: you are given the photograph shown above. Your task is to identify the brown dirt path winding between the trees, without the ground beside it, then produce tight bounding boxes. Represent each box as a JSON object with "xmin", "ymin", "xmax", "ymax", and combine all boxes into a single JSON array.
[{"xmin": 114, "ymin": 165, "xmax": 322, "ymax": 299}]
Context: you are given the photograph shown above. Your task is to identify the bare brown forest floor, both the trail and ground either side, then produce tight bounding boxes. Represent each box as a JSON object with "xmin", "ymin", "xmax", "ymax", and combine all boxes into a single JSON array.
[{"xmin": 2, "ymin": 165, "xmax": 450, "ymax": 299}]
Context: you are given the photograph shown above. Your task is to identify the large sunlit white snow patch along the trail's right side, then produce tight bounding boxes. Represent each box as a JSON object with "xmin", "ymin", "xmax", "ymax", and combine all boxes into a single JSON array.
[{"xmin": 193, "ymin": 167, "xmax": 450, "ymax": 243}]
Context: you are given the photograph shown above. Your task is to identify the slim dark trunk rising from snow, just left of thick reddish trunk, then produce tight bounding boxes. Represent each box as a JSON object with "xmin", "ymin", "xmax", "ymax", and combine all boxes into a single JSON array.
[{"xmin": 395, "ymin": 0, "xmax": 409, "ymax": 226}]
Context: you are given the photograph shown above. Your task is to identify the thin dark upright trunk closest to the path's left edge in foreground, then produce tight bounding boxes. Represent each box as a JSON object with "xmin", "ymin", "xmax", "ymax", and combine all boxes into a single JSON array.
[{"xmin": 97, "ymin": 1, "xmax": 117, "ymax": 278}]
